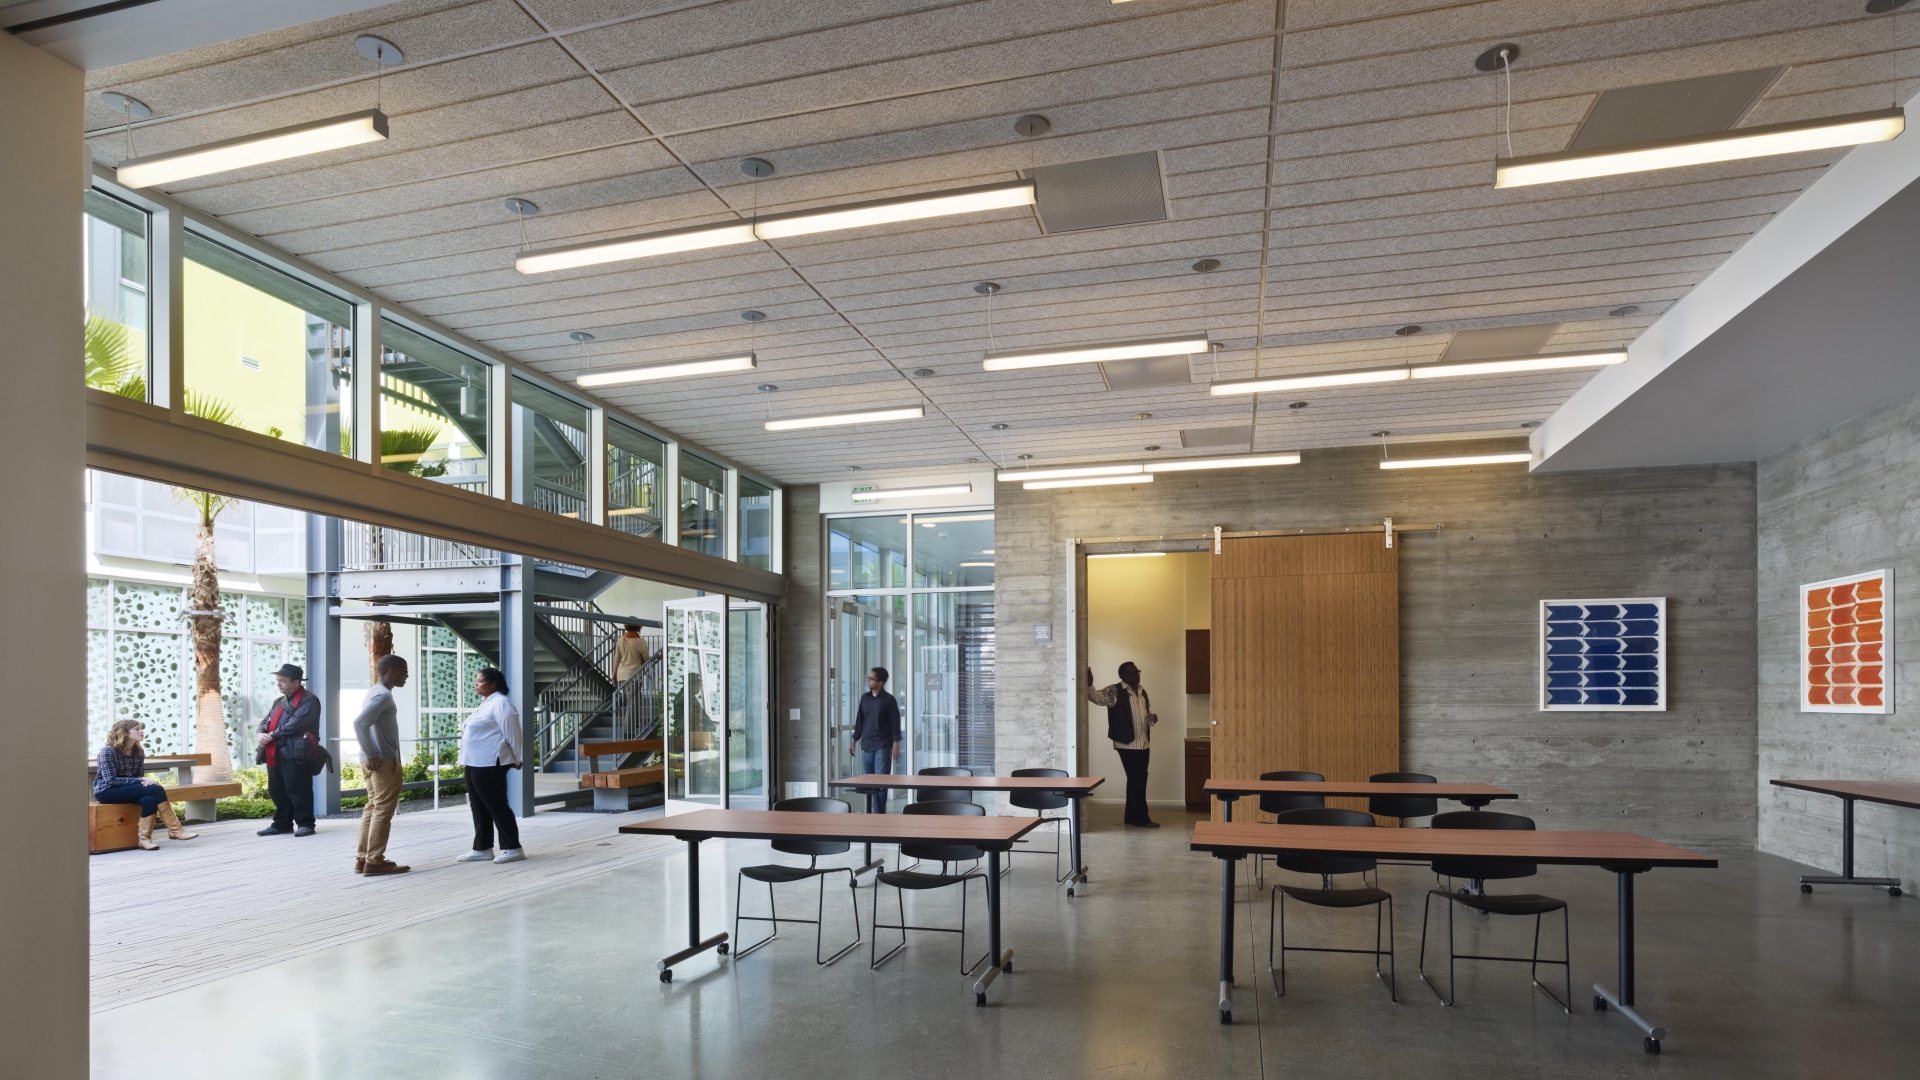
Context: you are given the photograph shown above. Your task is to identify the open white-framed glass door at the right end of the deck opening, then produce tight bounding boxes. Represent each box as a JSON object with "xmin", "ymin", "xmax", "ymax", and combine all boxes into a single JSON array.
[{"xmin": 664, "ymin": 596, "xmax": 728, "ymax": 815}]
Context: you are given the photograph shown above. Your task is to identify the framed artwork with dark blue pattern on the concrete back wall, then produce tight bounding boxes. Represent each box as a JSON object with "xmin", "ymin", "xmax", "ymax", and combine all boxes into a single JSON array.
[{"xmin": 1540, "ymin": 596, "xmax": 1667, "ymax": 713}]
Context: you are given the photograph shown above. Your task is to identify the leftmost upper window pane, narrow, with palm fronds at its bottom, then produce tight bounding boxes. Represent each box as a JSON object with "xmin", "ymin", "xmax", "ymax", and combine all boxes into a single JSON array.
[{"xmin": 83, "ymin": 190, "xmax": 150, "ymax": 402}]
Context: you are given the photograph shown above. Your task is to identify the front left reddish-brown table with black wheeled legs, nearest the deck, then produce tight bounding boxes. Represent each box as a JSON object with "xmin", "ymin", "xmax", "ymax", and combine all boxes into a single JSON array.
[{"xmin": 620, "ymin": 809, "xmax": 1041, "ymax": 1005}]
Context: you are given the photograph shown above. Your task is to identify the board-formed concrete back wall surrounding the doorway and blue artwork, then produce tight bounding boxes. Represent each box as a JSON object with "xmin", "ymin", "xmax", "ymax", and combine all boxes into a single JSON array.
[{"xmin": 995, "ymin": 444, "xmax": 1757, "ymax": 847}]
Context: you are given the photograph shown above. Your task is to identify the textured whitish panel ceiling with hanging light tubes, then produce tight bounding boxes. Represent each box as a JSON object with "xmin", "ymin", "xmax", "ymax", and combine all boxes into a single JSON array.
[{"xmin": 74, "ymin": 0, "xmax": 1920, "ymax": 482}]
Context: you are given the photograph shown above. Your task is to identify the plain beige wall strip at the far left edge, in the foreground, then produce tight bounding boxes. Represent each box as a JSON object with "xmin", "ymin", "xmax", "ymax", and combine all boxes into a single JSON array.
[{"xmin": 0, "ymin": 35, "xmax": 88, "ymax": 1080}]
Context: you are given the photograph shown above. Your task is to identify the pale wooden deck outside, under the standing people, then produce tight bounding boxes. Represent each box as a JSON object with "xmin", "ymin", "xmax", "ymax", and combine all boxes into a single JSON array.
[{"xmin": 88, "ymin": 807, "xmax": 680, "ymax": 1013}]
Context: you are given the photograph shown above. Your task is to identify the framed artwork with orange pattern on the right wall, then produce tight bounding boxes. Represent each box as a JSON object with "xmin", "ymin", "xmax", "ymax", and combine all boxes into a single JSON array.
[{"xmin": 1799, "ymin": 569, "xmax": 1893, "ymax": 713}]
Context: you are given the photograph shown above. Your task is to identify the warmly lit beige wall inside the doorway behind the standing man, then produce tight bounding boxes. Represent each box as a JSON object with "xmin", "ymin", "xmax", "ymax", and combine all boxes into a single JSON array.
[{"xmin": 1087, "ymin": 552, "xmax": 1210, "ymax": 803}]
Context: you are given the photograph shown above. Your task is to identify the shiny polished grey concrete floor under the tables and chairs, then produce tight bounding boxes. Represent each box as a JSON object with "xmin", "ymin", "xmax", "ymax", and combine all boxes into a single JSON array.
[{"xmin": 92, "ymin": 809, "xmax": 1920, "ymax": 1080}]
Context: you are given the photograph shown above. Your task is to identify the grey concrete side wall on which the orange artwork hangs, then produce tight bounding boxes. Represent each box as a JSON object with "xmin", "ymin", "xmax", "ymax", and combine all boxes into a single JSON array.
[{"xmin": 1757, "ymin": 386, "xmax": 1920, "ymax": 880}]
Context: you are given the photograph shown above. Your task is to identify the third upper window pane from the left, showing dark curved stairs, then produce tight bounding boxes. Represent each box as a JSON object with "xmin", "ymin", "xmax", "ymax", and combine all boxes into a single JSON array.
[{"xmin": 380, "ymin": 319, "xmax": 492, "ymax": 492}]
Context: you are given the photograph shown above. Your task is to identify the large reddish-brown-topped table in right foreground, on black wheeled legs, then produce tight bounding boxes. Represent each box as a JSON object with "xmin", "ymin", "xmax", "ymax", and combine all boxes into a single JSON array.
[{"xmin": 1192, "ymin": 818, "xmax": 1720, "ymax": 1053}]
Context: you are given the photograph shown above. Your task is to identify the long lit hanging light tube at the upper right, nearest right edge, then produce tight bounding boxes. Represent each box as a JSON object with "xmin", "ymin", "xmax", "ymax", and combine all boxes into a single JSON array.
[{"xmin": 1494, "ymin": 110, "xmax": 1907, "ymax": 188}]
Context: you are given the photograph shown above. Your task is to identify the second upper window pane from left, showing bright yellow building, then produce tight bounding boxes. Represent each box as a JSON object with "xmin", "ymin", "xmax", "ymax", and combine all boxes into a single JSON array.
[{"xmin": 182, "ymin": 233, "xmax": 353, "ymax": 454}]
